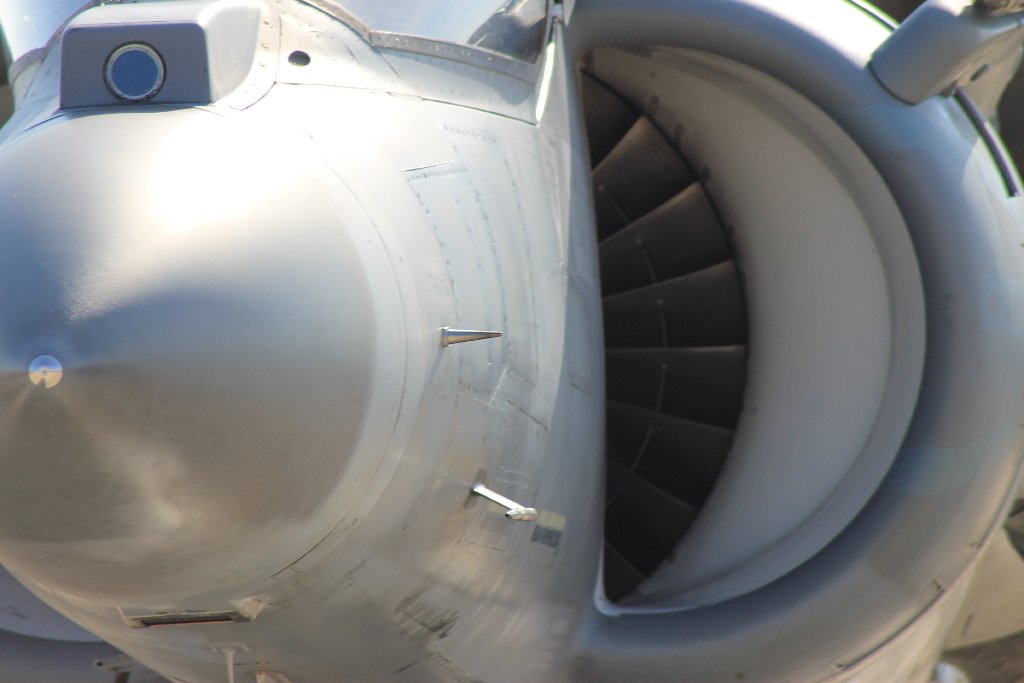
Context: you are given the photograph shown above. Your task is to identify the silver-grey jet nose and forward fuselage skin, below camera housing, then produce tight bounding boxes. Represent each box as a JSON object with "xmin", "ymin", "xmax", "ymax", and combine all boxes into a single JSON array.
[{"xmin": 0, "ymin": 3, "xmax": 602, "ymax": 683}]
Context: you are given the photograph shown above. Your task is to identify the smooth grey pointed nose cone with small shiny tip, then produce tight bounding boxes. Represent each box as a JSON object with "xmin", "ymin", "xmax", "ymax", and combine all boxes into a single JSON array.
[{"xmin": 0, "ymin": 111, "xmax": 389, "ymax": 604}]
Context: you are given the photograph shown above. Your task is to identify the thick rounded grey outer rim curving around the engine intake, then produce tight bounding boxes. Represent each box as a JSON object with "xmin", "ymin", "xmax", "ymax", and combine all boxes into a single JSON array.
[{"xmin": 573, "ymin": 2, "xmax": 1022, "ymax": 680}]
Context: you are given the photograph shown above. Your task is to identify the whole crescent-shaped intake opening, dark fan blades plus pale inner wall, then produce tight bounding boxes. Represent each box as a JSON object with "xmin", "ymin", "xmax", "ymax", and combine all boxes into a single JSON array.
[{"xmin": 583, "ymin": 48, "xmax": 925, "ymax": 610}]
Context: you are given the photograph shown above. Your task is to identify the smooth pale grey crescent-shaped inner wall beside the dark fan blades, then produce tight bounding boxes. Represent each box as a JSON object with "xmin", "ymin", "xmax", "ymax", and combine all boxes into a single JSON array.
[{"xmin": 587, "ymin": 49, "xmax": 926, "ymax": 608}]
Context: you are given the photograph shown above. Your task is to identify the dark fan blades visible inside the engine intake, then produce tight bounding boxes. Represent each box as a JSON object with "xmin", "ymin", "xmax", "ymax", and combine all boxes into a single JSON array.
[{"xmin": 582, "ymin": 73, "xmax": 746, "ymax": 600}]
